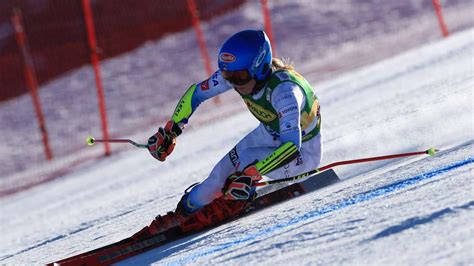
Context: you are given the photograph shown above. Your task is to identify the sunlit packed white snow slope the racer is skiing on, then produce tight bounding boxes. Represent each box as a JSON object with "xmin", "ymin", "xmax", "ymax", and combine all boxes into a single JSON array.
[{"xmin": 0, "ymin": 29, "xmax": 474, "ymax": 265}]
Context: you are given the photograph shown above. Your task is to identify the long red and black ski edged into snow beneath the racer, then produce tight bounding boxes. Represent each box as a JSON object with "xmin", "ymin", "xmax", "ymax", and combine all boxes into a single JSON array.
[{"xmin": 48, "ymin": 169, "xmax": 339, "ymax": 265}]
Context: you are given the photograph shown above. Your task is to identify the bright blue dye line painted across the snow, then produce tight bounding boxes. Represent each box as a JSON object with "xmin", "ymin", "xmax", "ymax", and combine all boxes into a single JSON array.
[{"xmin": 167, "ymin": 157, "xmax": 474, "ymax": 265}]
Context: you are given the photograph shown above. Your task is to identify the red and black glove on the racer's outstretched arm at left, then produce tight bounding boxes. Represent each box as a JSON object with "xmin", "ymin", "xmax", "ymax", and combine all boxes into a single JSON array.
[{"xmin": 148, "ymin": 121, "xmax": 182, "ymax": 162}]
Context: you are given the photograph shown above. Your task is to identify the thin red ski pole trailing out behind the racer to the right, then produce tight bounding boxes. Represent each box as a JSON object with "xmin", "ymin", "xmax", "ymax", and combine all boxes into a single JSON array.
[{"xmin": 255, "ymin": 148, "xmax": 439, "ymax": 186}]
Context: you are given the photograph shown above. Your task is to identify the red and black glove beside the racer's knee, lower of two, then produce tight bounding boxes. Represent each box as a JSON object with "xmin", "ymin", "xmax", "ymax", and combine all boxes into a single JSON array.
[{"xmin": 223, "ymin": 165, "xmax": 262, "ymax": 200}]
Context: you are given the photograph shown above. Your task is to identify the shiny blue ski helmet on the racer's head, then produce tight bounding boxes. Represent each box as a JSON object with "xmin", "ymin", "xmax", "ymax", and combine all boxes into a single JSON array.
[{"xmin": 218, "ymin": 30, "xmax": 272, "ymax": 80}]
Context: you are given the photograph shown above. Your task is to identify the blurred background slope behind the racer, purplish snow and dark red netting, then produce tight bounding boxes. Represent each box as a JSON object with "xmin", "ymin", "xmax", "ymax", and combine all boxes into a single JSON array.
[{"xmin": 0, "ymin": 0, "xmax": 474, "ymax": 195}]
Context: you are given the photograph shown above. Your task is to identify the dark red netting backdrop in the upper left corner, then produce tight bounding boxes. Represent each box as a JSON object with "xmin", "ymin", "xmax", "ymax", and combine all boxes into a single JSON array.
[{"xmin": 0, "ymin": 0, "xmax": 244, "ymax": 101}]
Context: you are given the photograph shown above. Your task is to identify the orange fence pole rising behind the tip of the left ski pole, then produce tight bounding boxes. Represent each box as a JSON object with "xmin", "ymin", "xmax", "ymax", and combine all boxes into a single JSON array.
[{"xmin": 82, "ymin": 0, "xmax": 110, "ymax": 155}]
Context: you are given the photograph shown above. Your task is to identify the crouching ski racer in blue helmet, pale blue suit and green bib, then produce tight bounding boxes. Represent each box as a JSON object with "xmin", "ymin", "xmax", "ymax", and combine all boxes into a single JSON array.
[{"xmin": 148, "ymin": 30, "xmax": 322, "ymax": 231}]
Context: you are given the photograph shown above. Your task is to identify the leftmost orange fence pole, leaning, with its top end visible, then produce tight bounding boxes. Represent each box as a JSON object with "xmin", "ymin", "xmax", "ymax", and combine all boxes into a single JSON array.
[{"xmin": 11, "ymin": 9, "xmax": 53, "ymax": 160}]
